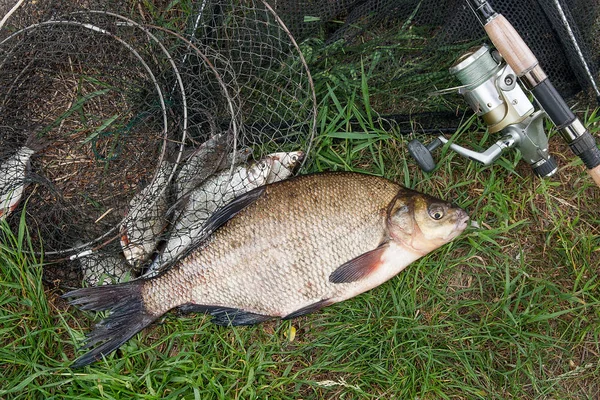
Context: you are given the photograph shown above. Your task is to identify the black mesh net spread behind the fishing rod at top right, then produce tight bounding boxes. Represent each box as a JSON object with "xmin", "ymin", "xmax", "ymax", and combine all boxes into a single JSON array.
[{"xmin": 272, "ymin": 0, "xmax": 600, "ymax": 125}]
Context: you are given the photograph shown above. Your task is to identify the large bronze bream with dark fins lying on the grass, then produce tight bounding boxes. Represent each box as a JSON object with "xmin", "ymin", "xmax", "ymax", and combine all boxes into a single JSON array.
[{"xmin": 65, "ymin": 173, "xmax": 468, "ymax": 367}]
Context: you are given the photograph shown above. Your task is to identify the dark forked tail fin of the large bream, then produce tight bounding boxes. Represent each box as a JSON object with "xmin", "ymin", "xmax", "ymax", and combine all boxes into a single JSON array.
[{"xmin": 63, "ymin": 281, "xmax": 159, "ymax": 368}]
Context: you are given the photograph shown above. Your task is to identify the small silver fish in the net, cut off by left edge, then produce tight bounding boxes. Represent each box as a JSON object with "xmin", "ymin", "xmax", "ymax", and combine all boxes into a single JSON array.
[{"xmin": 0, "ymin": 145, "xmax": 35, "ymax": 218}]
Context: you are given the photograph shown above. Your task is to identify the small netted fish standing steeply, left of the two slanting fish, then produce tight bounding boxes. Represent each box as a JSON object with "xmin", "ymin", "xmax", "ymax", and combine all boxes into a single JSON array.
[{"xmin": 120, "ymin": 160, "xmax": 173, "ymax": 266}]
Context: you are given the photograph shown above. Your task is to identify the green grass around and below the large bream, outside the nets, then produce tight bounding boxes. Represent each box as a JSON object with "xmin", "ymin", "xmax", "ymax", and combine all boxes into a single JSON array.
[{"xmin": 0, "ymin": 6, "xmax": 600, "ymax": 399}]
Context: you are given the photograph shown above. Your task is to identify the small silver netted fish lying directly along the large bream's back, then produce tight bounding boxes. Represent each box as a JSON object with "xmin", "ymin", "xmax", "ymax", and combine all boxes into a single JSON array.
[{"xmin": 144, "ymin": 157, "xmax": 275, "ymax": 276}]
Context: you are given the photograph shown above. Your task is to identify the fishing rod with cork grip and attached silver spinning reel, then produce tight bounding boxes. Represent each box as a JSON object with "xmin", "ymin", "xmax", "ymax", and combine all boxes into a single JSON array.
[{"xmin": 409, "ymin": 0, "xmax": 600, "ymax": 186}]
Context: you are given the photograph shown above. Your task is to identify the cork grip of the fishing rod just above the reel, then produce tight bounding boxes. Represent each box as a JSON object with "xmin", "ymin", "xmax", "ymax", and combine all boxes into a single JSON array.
[{"xmin": 484, "ymin": 14, "xmax": 538, "ymax": 76}]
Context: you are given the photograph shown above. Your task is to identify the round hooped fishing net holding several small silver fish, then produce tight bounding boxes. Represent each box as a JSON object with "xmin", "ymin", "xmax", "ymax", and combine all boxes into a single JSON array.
[{"xmin": 0, "ymin": 1, "xmax": 316, "ymax": 286}]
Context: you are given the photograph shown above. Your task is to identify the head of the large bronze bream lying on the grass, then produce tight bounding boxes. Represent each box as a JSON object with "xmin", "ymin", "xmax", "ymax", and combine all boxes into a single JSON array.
[{"xmin": 387, "ymin": 189, "xmax": 469, "ymax": 255}]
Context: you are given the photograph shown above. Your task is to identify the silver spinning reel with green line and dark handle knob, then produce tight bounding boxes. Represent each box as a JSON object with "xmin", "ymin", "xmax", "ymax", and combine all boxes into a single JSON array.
[{"xmin": 408, "ymin": 45, "xmax": 557, "ymax": 177}]
